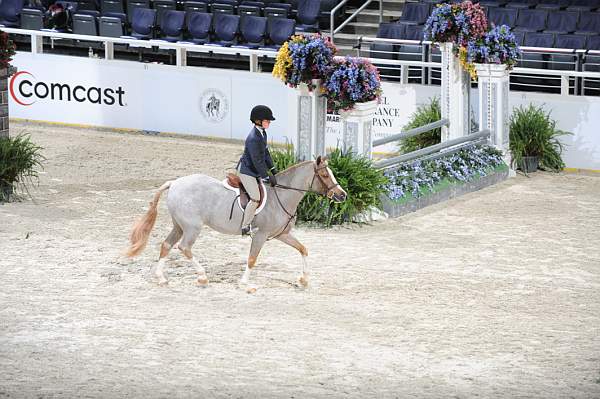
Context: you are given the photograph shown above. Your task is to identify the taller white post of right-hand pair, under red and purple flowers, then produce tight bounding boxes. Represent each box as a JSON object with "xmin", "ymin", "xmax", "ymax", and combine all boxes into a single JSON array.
[{"xmin": 440, "ymin": 43, "xmax": 471, "ymax": 142}]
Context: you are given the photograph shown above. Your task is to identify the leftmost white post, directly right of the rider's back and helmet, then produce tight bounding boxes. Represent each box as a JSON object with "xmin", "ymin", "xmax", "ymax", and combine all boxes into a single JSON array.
[{"xmin": 296, "ymin": 79, "xmax": 327, "ymax": 161}]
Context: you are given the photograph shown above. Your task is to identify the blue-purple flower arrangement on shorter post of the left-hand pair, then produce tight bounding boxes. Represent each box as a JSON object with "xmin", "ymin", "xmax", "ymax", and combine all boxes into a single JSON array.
[{"xmin": 323, "ymin": 57, "xmax": 381, "ymax": 112}]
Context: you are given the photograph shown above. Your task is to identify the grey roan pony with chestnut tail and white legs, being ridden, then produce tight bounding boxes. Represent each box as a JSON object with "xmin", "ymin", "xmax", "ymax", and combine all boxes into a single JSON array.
[{"xmin": 126, "ymin": 156, "xmax": 347, "ymax": 292}]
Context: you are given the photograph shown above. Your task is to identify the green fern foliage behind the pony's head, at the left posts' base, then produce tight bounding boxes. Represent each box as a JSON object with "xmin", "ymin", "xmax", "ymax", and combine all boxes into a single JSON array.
[{"xmin": 271, "ymin": 145, "xmax": 387, "ymax": 226}]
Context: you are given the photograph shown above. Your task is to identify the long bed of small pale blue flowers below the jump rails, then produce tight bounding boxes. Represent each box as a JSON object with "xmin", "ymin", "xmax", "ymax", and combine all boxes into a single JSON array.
[{"xmin": 384, "ymin": 146, "xmax": 506, "ymax": 201}]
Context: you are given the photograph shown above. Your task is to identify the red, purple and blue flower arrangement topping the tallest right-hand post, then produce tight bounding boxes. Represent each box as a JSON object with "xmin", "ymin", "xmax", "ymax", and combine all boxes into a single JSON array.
[{"xmin": 424, "ymin": 0, "xmax": 488, "ymax": 47}]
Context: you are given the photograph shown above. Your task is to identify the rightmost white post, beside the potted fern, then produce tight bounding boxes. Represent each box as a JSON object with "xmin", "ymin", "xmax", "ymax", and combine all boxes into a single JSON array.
[{"xmin": 475, "ymin": 64, "xmax": 511, "ymax": 173}]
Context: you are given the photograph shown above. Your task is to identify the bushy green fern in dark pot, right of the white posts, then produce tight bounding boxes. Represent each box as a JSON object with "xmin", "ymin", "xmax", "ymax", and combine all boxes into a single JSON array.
[{"xmin": 510, "ymin": 104, "xmax": 571, "ymax": 172}]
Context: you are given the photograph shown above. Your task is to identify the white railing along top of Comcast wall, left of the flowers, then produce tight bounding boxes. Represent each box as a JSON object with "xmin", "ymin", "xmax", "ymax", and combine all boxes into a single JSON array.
[{"xmin": 2, "ymin": 28, "xmax": 277, "ymax": 72}]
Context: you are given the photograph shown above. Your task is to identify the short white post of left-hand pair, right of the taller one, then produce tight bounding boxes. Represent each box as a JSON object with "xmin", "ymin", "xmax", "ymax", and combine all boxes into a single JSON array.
[{"xmin": 340, "ymin": 101, "xmax": 377, "ymax": 159}]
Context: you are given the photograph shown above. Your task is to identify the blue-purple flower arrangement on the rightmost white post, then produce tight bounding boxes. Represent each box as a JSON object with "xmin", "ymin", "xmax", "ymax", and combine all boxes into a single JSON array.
[{"xmin": 466, "ymin": 25, "xmax": 521, "ymax": 78}]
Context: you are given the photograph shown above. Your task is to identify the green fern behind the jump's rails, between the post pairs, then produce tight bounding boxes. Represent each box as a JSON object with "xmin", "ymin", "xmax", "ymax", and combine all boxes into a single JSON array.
[{"xmin": 399, "ymin": 97, "xmax": 442, "ymax": 154}]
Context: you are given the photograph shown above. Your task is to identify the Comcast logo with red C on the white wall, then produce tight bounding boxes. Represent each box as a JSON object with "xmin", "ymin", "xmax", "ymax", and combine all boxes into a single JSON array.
[{"xmin": 9, "ymin": 71, "xmax": 126, "ymax": 107}]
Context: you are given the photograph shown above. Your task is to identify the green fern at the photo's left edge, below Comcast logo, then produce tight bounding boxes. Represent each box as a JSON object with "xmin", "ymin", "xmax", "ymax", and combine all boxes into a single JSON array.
[{"xmin": 0, "ymin": 135, "xmax": 46, "ymax": 201}]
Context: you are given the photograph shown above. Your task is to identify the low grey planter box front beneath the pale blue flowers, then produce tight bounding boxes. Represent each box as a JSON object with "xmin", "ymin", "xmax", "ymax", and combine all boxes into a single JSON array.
[{"xmin": 381, "ymin": 165, "xmax": 509, "ymax": 217}]
